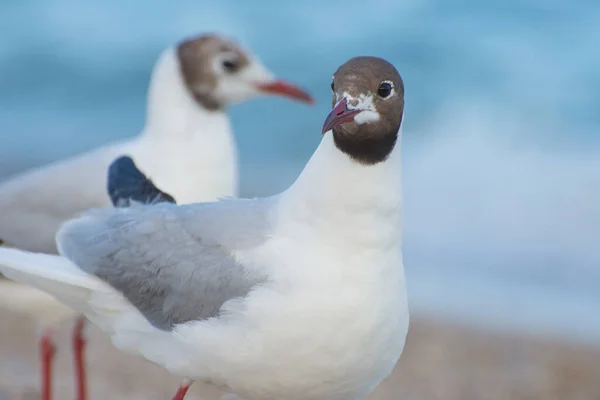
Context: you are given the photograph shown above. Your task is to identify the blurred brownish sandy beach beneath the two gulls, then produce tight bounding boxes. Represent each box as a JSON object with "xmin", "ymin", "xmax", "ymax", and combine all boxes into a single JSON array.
[{"xmin": 0, "ymin": 311, "xmax": 600, "ymax": 400}]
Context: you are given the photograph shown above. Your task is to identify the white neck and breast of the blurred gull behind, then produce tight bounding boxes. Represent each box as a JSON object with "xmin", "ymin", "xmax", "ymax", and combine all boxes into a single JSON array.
[{"xmin": 132, "ymin": 48, "xmax": 238, "ymax": 204}]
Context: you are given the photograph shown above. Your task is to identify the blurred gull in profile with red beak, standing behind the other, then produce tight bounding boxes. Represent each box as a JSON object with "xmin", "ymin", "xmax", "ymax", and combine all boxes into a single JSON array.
[{"xmin": 0, "ymin": 34, "xmax": 313, "ymax": 400}]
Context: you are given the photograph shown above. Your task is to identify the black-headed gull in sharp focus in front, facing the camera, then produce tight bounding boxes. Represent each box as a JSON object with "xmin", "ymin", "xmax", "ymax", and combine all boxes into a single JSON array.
[{"xmin": 0, "ymin": 57, "xmax": 409, "ymax": 400}]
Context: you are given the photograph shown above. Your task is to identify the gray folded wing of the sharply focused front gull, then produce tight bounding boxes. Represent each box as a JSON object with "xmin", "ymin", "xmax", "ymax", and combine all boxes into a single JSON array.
[{"xmin": 57, "ymin": 199, "xmax": 268, "ymax": 330}]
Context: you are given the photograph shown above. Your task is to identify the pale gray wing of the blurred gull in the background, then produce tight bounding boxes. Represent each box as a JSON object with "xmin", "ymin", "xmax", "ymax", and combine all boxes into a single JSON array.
[{"xmin": 0, "ymin": 143, "xmax": 132, "ymax": 253}]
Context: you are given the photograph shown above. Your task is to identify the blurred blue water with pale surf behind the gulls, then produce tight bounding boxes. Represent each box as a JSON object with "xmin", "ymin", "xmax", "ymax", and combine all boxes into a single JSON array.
[{"xmin": 0, "ymin": 0, "xmax": 600, "ymax": 341}]
